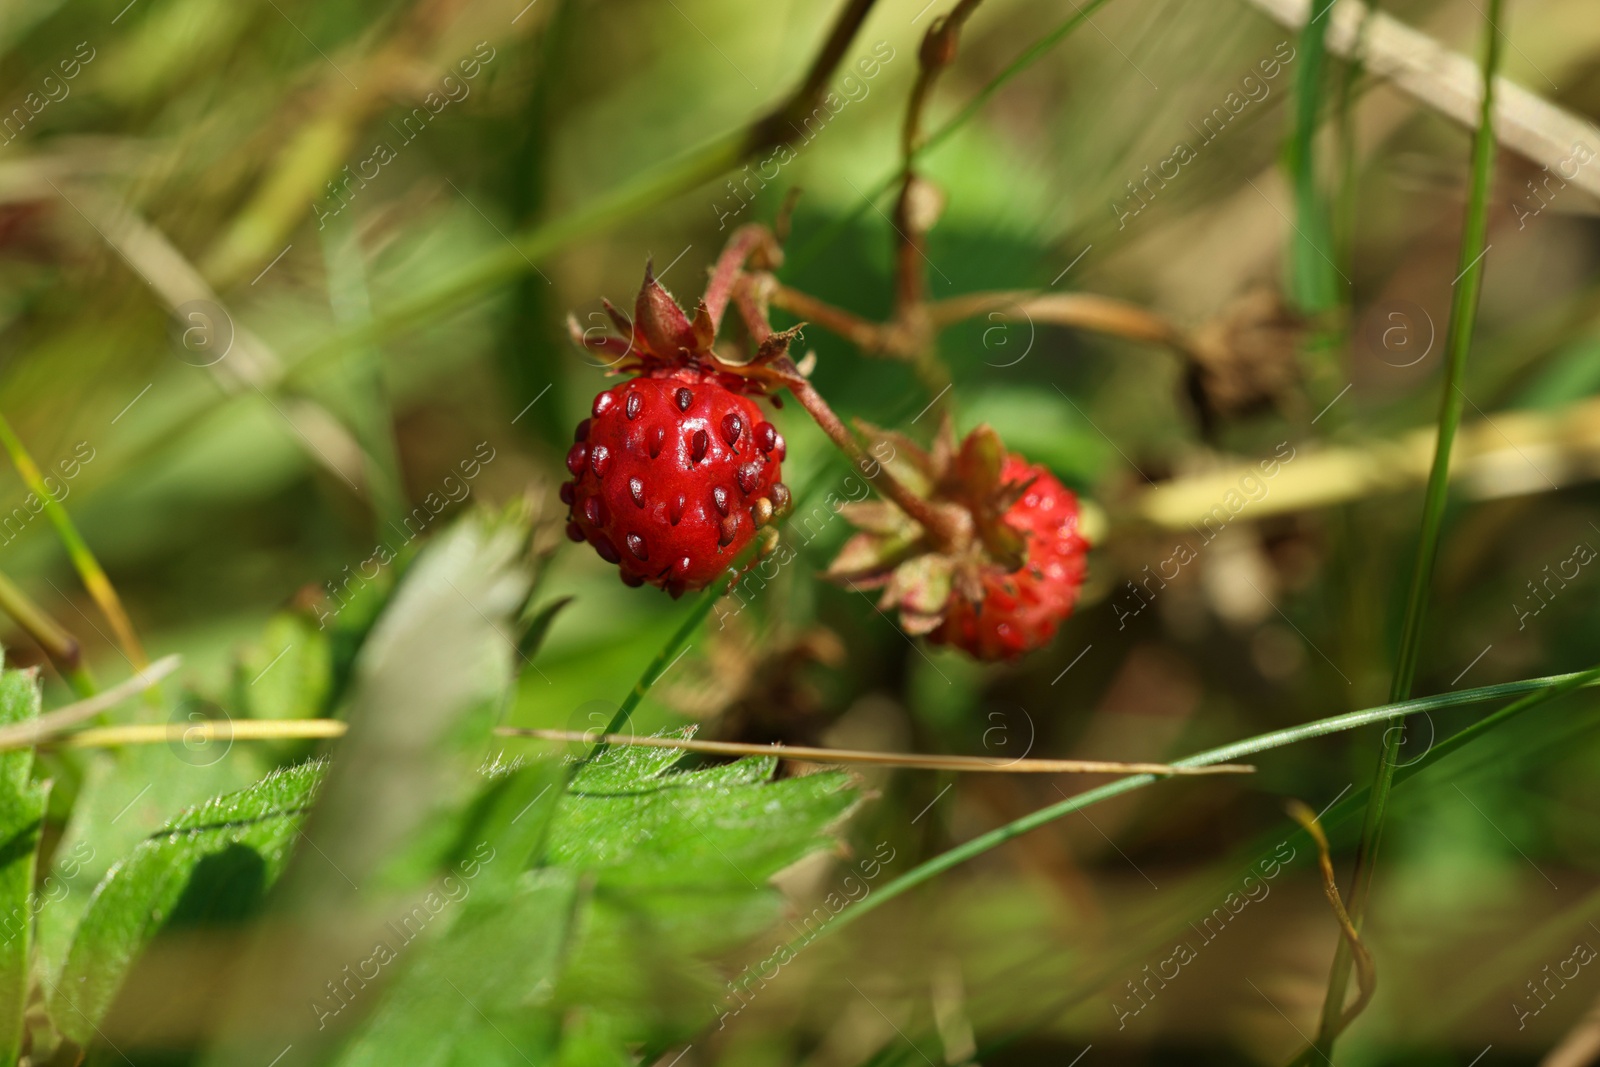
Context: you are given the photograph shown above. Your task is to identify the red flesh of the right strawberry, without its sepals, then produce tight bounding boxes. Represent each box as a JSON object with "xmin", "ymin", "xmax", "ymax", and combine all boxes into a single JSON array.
[{"xmin": 928, "ymin": 454, "xmax": 1090, "ymax": 659}]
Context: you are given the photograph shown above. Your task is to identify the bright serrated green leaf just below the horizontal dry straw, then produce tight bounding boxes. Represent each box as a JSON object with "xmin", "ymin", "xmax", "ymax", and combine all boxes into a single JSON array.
[{"xmin": 544, "ymin": 745, "xmax": 859, "ymax": 1046}]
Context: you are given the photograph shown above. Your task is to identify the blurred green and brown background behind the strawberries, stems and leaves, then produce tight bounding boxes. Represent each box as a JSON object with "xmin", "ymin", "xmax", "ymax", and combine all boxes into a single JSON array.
[{"xmin": 0, "ymin": 0, "xmax": 1600, "ymax": 1067}]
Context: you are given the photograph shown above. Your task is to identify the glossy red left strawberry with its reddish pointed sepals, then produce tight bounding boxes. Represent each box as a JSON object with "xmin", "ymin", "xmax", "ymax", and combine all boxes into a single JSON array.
[{"xmin": 562, "ymin": 259, "xmax": 790, "ymax": 597}]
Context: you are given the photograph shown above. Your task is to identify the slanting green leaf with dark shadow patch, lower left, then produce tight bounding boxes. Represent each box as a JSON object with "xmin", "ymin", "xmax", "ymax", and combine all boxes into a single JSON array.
[{"xmin": 50, "ymin": 761, "xmax": 325, "ymax": 1045}]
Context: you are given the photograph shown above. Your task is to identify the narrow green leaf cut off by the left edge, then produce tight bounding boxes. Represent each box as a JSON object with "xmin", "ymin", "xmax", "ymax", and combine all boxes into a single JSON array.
[{"xmin": 0, "ymin": 670, "xmax": 48, "ymax": 1064}]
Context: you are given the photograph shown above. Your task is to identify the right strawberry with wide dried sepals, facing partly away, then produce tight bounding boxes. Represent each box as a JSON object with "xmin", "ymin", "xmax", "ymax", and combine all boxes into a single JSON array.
[{"xmin": 829, "ymin": 421, "xmax": 1090, "ymax": 659}]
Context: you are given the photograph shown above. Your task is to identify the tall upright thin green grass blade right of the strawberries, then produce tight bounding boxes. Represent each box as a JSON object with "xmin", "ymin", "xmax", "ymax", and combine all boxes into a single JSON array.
[{"xmin": 1315, "ymin": 0, "xmax": 1502, "ymax": 1056}]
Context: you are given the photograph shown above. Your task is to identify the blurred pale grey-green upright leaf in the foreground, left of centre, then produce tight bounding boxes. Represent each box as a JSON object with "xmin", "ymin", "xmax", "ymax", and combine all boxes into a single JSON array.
[{"xmin": 205, "ymin": 509, "xmax": 534, "ymax": 1064}]
